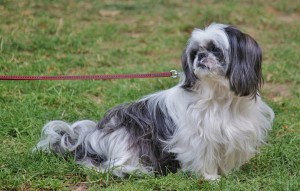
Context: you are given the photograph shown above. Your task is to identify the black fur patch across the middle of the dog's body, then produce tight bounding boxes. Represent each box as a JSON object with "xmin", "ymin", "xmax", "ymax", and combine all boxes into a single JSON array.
[{"xmin": 97, "ymin": 100, "xmax": 180, "ymax": 174}]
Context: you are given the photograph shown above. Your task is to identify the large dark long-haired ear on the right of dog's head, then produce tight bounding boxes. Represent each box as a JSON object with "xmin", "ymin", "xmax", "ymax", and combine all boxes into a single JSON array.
[{"xmin": 224, "ymin": 26, "xmax": 263, "ymax": 98}]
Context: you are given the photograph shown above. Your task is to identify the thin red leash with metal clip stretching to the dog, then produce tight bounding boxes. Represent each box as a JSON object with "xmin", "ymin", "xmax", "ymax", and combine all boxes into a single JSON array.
[{"xmin": 0, "ymin": 70, "xmax": 179, "ymax": 80}]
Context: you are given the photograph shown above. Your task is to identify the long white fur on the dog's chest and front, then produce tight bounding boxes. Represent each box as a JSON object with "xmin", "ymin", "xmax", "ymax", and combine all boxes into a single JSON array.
[{"xmin": 166, "ymin": 84, "xmax": 274, "ymax": 177}]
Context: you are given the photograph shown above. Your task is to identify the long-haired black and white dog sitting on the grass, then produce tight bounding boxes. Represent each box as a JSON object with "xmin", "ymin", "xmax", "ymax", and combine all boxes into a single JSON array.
[{"xmin": 36, "ymin": 24, "xmax": 274, "ymax": 180}]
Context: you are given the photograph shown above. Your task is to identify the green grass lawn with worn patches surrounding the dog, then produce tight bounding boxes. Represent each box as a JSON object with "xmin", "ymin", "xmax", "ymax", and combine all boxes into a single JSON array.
[{"xmin": 0, "ymin": 0, "xmax": 300, "ymax": 190}]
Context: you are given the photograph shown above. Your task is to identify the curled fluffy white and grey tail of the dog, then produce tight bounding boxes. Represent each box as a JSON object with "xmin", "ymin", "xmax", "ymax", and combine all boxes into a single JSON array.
[{"xmin": 34, "ymin": 120, "xmax": 96, "ymax": 155}]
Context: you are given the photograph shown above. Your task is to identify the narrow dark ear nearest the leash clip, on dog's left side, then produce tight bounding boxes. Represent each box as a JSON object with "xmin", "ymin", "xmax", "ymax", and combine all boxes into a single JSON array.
[{"xmin": 181, "ymin": 48, "xmax": 197, "ymax": 90}]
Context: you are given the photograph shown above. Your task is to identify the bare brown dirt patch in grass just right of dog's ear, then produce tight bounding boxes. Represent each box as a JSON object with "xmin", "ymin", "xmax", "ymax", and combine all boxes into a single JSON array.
[{"xmin": 262, "ymin": 83, "xmax": 293, "ymax": 102}]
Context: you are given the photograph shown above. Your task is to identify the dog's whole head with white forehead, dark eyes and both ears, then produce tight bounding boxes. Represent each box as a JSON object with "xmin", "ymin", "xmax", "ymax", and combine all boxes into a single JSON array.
[{"xmin": 182, "ymin": 24, "xmax": 262, "ymax": 97}]
